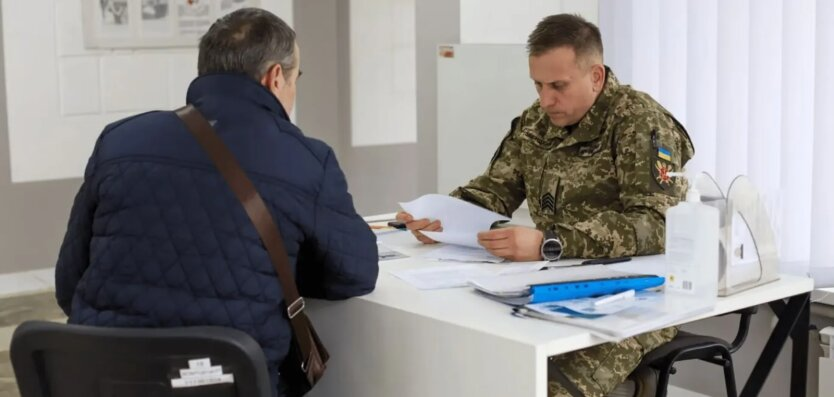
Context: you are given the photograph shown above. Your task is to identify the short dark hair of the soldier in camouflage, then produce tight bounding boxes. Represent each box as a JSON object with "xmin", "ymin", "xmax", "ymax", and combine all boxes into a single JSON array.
[{"xmin": 527, "ymin": 14, "xmax": 602, "ymax": 62}]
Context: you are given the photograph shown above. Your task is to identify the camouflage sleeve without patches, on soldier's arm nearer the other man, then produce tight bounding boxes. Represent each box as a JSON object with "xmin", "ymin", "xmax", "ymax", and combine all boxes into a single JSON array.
[{"xmin": 450, "ymin": 116, "xmax": 525, "ymax": 216}]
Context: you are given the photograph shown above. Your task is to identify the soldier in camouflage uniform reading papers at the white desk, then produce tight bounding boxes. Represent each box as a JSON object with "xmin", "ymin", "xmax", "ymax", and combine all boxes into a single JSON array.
[{"xmin": 397, "ymin": 14, "xmax": 694, "ymax": 397}]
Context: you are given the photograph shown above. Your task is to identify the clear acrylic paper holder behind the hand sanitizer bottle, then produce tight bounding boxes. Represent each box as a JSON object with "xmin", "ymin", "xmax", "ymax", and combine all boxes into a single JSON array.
[{"xmin": 695, "ymin": 173, "xmax": 779, "ymax": 296}]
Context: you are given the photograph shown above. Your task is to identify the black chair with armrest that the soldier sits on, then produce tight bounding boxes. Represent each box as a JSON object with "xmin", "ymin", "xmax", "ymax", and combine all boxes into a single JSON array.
[{"xmin": 632, "ymin": 307, "xmax": 758, "ymax": 397}]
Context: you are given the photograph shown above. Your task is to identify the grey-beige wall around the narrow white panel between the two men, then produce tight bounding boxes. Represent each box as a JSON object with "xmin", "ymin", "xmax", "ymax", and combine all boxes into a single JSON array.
[{"xmin": 293, "ymin": 0, "xmax": 460, "ymax": 214}]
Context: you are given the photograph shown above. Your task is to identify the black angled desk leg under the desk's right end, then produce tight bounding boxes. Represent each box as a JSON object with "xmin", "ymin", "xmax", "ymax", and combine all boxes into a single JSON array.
[{"xmin": 741, "ymin": 293, "xmax": 811, "ymax": 397}]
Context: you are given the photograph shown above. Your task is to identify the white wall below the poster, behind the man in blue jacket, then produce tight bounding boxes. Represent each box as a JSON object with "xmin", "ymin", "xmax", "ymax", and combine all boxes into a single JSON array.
[{"xmin": 2, "ymin": 0, "xmax": 292, "ymax": 182}]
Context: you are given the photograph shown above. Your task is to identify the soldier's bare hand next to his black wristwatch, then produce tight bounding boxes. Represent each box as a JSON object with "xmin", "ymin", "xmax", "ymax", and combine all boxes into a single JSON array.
[{"xmin": 478, "ymin": 226, "xmax": 544, "ymax": 262}]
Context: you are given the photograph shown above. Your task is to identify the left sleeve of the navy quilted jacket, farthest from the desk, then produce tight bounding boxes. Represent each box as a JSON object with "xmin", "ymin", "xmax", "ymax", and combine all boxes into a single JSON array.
[{"xmin": 55, "ymin": 140, "xmax": 100, "ymax": 316}]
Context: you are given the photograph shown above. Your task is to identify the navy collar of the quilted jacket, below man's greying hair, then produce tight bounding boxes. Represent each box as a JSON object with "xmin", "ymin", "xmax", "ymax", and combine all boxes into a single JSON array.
[{"xmin": 185, "ymin": 73, "xmax": 290, "ymax": 120}]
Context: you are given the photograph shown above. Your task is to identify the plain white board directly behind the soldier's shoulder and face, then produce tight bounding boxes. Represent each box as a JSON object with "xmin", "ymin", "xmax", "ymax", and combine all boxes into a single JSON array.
[{"xmin": 437, "ymin": 44, "xmax": 536, "ymax": 193}]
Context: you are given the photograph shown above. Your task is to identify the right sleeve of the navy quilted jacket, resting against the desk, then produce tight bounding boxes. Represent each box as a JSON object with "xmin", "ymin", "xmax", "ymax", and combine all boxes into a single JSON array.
[{"xmin": 297, "ymin": 150, "xmax": 379, "ymax": 299}]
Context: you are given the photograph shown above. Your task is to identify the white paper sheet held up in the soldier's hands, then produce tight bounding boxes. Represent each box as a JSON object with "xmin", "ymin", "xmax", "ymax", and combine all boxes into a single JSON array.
[{"xmin": 400, "ymin": 194, "xmax": 510, "ymax": 248}]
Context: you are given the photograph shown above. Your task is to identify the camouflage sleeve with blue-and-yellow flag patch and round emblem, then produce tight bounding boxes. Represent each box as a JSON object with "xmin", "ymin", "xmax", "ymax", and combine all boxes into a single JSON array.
[{"xmin": 559, "ymin": 113, "xmax": 694, "ymax": 258}]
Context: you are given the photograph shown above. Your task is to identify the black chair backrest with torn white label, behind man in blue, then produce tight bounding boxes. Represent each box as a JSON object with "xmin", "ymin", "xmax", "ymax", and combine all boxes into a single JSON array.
[{"xmin": 10, "ymin": 321, "xmax": 273, "ymax": 397}]
